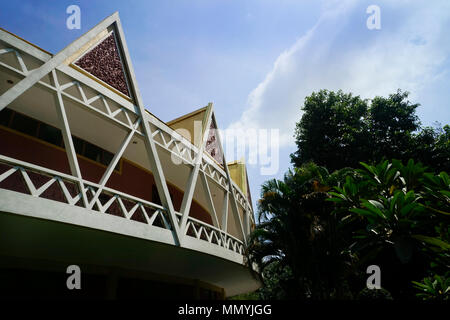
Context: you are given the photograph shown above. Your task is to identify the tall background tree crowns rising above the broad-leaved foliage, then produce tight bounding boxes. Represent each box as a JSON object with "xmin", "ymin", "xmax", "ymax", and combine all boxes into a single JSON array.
[{"xmin": 291, "ymin": 90, "xmax": 450, "ymax": 172}]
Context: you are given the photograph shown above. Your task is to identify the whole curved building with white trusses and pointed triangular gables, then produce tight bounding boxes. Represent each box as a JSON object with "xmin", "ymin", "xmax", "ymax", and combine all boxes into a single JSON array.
[{"xmin": 0, "ymin": 13, "xmax": 260, "ymax": 299}]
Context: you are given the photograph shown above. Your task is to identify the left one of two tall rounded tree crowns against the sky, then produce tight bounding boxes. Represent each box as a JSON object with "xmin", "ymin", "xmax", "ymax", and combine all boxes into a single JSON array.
[{"xmin": 291, "ymin": 90, "xmax": 369, "ymax": 170}]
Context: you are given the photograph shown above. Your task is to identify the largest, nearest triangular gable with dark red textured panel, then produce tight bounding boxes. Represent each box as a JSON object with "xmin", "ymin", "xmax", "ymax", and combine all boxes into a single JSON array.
[{"xmin": 65, "ymin": 14, "xmax": 133, "ymax": 100}]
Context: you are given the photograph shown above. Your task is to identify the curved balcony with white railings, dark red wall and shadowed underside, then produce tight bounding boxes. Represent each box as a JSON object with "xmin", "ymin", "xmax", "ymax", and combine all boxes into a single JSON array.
[{"xmin": 0, "ymin": 15, "xmax": 259, "ymax": 295}]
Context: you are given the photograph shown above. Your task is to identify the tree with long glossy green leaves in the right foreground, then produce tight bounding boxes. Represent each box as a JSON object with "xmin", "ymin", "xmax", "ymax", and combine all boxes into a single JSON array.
[{"xmin": 328, "ymin": 160, "xmax": 450, "ymax": 297}]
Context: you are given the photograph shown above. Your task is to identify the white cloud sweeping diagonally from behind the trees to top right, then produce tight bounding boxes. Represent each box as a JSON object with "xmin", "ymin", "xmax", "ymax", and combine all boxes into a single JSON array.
[{"xmin": 228, "ymin": 1, "xmax": 450, "ymax": 147}]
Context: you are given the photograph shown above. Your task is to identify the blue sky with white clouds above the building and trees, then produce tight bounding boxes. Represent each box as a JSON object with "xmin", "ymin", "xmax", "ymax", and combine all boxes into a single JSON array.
[{"xmin": 0, "ymin": 0, "xmax": 450, "ymax": 212}]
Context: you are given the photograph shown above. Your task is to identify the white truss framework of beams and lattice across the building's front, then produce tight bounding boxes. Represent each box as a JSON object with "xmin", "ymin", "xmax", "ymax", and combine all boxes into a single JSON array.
[{"xmin": 0, "ymin": 13, "xmax": 254, "ymax": 260}]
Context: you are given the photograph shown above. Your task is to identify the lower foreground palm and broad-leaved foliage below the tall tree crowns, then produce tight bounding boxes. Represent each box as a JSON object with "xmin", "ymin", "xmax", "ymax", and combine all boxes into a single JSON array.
[{"xmin": 247, "ymin": 160, "xmax": 450, "ymax": 300}]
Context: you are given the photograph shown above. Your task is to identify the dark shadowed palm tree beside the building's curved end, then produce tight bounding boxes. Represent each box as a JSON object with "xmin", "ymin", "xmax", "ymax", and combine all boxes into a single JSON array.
[{"xmin": 247, "ymin": 163, "xmax": 356, "ymax": 299}]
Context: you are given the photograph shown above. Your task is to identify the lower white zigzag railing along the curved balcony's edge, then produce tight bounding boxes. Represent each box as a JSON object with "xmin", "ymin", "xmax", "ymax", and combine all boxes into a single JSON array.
[{"xmin": 0, "ymin": 155, "xmax": 244, "ymax": 255}]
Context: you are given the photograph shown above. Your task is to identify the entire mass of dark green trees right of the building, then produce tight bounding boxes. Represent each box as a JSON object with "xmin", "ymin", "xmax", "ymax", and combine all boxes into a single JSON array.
[{"xmin": 247, "ymin": 90, "xmax": 450, "ymax": 300}]
